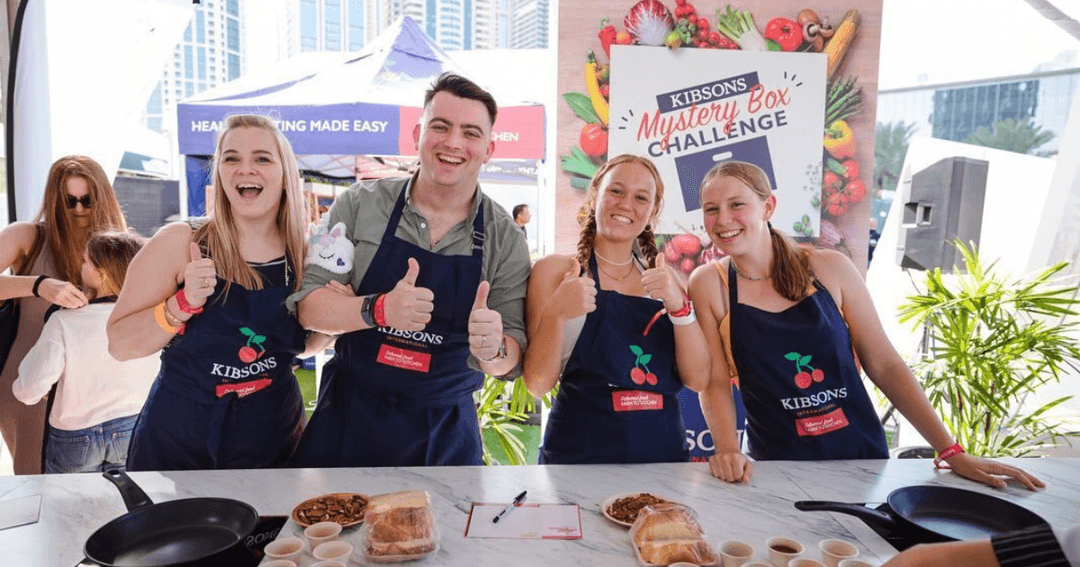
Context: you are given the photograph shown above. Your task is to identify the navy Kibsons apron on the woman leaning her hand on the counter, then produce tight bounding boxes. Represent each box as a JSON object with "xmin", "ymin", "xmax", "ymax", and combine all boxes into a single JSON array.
[{"xmin": 728, "ymin": 264, "xmax": 889, "ymax": 460}]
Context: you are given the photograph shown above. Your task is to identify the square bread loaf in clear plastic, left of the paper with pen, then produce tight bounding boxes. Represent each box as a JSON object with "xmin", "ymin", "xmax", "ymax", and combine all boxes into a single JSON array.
[{"xmin": 364, "ymin": 490, "xmax": 435, "ymax": 557}]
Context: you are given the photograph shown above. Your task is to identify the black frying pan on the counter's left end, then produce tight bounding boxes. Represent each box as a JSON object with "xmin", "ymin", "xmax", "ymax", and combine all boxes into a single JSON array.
[{"xmin": 83, "ymin": 471, "xmax": 259, "ymax": 567}]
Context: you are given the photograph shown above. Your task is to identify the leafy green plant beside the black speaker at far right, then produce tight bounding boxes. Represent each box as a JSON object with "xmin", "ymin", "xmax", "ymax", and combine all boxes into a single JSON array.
[{"xmin": 900, "ymin": 242, "xmax": 1080, "ymax": 457}]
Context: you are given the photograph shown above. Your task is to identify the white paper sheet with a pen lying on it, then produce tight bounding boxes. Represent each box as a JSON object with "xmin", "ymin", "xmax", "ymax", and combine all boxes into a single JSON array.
[{"xmin": 465, "ymin": 502, "xmax": 581, "ymax": 539}]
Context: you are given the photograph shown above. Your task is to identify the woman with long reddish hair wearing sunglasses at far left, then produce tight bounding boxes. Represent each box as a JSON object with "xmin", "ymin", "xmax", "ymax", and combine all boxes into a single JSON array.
[{"xmin": 0, "ymin": 156, "xmax": 127, "ymax": 474}]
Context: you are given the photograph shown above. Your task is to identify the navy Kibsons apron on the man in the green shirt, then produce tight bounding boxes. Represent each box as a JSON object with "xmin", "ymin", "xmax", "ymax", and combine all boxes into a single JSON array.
[{"xmin": 294, "ymin": 189, "xmax": 484, "ymax": 467}]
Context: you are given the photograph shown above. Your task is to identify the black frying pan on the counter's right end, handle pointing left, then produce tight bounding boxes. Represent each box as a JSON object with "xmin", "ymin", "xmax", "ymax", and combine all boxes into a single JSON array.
[{"xmin": 795, "ymin": 486, "xmax": 1047, "ymax": 541}]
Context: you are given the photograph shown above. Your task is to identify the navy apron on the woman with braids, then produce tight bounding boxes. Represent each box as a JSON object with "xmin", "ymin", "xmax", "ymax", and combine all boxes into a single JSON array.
[{"xmin": 540, "ymin": 253, "xmax": 690, "ymax": 464}]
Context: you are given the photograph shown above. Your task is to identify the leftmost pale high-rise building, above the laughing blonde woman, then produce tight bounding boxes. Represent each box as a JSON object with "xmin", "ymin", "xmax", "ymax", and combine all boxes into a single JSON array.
[{"xmin": 146, "ymin": 0, "xmax": 244, "ymax": 132}]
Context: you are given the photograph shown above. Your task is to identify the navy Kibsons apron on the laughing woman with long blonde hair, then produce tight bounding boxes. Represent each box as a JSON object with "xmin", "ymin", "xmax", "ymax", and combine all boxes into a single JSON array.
[{"xmin": 127, "ymin": 261, "xmax": 307, "ymax": 471}]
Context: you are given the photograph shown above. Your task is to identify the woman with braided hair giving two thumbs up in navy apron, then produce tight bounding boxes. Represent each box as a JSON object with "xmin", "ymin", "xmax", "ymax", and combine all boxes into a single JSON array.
[{"xmin": 524, "ymin": 154, "xmax": 710, "ymax": 463}]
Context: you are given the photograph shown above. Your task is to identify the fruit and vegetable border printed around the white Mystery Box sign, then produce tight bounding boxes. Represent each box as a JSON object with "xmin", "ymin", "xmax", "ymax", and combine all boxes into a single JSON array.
[{"xmin": 561, "ymin": 0, "xmax": 878, "ymax": 265}]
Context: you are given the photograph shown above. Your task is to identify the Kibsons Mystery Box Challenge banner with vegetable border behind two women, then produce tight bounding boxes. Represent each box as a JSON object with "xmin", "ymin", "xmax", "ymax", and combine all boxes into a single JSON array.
[{"xmin": 555, "ymin": 0, "xmax": 881, "ymax": 461}]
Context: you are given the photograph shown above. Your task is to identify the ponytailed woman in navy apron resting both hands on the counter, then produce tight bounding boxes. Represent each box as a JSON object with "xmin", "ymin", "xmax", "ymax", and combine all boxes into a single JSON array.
[{"xmin": 690, "ymin": 161, "xmax": 1043, "ymax": 490}]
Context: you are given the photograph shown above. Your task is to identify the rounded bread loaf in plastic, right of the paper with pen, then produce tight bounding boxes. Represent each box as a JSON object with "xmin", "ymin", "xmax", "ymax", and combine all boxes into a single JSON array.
[{"xmin": 630, "ymin": 502, "xmax": 719, "ymax": 565}]
